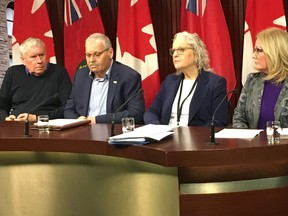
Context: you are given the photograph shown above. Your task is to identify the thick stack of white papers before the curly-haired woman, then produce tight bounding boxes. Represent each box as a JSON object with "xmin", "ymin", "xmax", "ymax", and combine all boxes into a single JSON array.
[{"xmin": 108, "ymin": 124, "xmax": 173, "ymax": 145}]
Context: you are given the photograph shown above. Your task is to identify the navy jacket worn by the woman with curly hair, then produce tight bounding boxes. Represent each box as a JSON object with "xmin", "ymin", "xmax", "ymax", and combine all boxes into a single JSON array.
[{"xmin": 144, "ymin": 70, "xmax": 228, "ymax": 126}]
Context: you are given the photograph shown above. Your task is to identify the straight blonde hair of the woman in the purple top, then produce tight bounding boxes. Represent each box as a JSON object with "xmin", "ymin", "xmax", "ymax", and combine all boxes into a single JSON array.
[{"xmin": 256, "ymin": 27, "xmax": 288, "ymax": 84}]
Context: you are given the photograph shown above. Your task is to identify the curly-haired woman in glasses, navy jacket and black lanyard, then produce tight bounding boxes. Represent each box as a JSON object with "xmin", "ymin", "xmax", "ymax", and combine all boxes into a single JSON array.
[{"xmin": 144, "ymin": 32, "xmax": 228, "ymax": 126}]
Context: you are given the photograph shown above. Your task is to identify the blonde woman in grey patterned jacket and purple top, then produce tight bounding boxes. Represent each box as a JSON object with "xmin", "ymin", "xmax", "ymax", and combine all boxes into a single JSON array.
[{"xmin": 233, "ymin": 27, "xmax": 288, "ymax": 129}]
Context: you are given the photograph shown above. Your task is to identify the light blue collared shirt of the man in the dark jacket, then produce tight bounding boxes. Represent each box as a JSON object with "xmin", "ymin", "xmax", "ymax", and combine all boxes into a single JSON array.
[{"xmin": 88, "ymin": 63, "xmax": 112, "ymax": 116}]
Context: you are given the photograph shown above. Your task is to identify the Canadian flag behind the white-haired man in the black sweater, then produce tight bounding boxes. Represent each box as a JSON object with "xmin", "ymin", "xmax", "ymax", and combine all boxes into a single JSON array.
[{"xmin": 12, "ymin": 0, "xmax": 56, "ymax": 64}]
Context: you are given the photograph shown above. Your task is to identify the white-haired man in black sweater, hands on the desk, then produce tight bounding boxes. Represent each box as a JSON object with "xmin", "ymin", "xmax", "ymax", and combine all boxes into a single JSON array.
[{"xmin": 0, "ymin": 38, "xmax": 71, "ymax": 121}]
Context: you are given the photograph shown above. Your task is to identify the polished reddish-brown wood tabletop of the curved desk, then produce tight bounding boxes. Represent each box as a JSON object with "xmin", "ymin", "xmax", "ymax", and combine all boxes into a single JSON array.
[{"xmin": 0, "ymin": 122, "xmax": 288, "ymax": 167}]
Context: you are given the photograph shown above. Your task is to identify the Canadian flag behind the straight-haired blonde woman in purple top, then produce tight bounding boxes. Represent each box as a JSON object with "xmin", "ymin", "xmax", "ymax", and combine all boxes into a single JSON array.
[{"xmin": 242, "ymin": 0, "xmax": 286, "ymax": 85}]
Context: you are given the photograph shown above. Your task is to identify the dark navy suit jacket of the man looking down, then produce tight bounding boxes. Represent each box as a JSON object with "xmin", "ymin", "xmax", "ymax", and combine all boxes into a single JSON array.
[{"xmin": 64, "ymin": 61, "xmax": 145, "ymax": 123}]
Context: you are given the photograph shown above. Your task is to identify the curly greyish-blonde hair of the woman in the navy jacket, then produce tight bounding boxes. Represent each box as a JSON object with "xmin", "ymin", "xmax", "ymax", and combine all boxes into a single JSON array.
[{"xmin": 173, "ymin": 31, "xmax": 213, "ymax": 71}]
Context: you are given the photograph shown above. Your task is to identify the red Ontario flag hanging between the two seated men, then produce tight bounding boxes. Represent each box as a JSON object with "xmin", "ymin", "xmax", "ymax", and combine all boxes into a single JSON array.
[{"xmin": 64, "ymin": 0, "xmax": 105, "ymax": 78}]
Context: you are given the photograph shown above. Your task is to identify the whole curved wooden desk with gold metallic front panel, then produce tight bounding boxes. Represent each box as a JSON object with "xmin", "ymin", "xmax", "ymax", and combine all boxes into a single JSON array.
[{"xmin": 0, "ymin": 122, "xmax": 288, "ymax": 216}]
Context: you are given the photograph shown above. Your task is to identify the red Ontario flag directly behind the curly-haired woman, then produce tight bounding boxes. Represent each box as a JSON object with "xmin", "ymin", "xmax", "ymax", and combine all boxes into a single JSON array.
[{"xmin": 180, "ymin": 0, "xmax": 236, "ymax": 91}]
